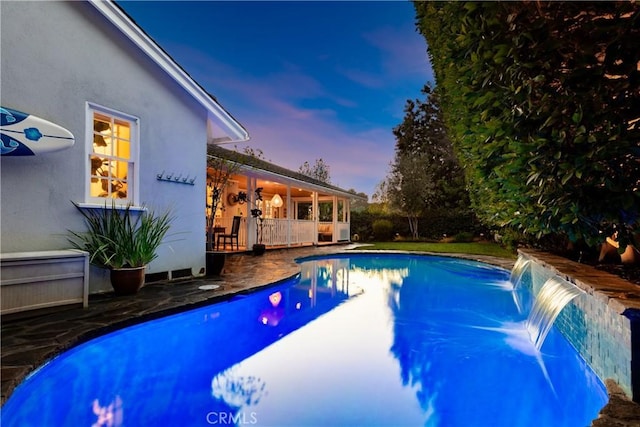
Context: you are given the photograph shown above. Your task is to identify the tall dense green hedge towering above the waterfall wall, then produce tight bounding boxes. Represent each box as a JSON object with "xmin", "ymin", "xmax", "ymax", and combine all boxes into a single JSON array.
[{"xmin": 414, "ymin": 1, "xmax": 640, "ymax": 244}]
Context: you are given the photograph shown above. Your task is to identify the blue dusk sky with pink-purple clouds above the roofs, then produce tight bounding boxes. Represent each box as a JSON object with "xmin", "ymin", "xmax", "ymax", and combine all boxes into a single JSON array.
[{"xmin": 118, "ymin": 1, "xmax": 433, "ymax": 196}]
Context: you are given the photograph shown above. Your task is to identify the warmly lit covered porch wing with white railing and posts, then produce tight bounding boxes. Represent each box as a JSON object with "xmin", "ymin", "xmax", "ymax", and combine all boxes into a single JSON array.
[{"xmin": 207, "ymin": 144, "xmax": 361, "ymax": 250}]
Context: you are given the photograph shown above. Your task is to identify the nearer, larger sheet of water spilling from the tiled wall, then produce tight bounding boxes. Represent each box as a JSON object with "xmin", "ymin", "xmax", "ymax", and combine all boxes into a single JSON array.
[{"xmin": 526, "ymin": 276, "xmax": 585, "ymax": 350}]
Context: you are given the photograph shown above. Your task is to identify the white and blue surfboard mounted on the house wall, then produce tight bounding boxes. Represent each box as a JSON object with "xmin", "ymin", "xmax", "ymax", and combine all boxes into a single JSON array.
[{"xmin": 0, "ymin": 107, "xmax": 75, "ymax": 156}]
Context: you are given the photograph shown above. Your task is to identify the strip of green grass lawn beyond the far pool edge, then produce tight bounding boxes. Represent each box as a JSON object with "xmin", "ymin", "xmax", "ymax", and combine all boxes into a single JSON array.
[{"xmin": 354, "ymin": 242, "xmax": 518, "ymax": 259}]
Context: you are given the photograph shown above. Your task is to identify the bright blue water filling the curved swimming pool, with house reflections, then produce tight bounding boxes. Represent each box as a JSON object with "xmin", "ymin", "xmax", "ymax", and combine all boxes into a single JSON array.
[{"xmin": 2, "ymin": 254, "xmax": 607, "ymax": 427}]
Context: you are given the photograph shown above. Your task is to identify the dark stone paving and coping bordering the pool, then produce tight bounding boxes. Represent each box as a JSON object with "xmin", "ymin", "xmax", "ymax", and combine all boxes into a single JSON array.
[{"xmin": 0, "ymin": 244, "xmax": 640, "ymax": 427}]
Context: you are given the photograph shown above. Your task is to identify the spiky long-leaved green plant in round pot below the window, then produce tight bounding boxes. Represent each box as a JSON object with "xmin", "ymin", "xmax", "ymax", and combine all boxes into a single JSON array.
[{"xmin": 68, "ymin": 202, "xmax": 173, "ymax": 295}]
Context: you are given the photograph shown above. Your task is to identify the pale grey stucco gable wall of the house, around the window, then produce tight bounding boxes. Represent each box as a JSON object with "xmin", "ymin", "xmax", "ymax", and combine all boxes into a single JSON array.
[{"xmin": 0, "ymin": 1, "xmax": 215, "ymax": 292}]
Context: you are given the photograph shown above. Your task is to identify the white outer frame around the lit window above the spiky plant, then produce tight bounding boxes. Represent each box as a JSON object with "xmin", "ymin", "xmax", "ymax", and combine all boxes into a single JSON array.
[{"xmin": 82, "ymin": 102, "xmax": 140, "ymax": 207}]
